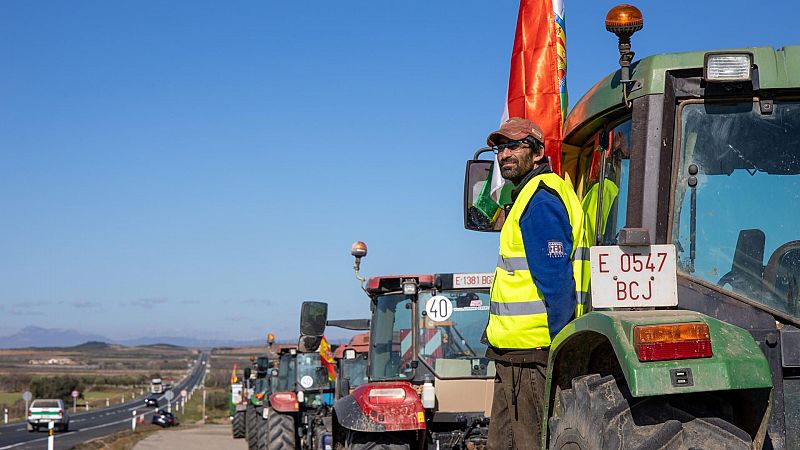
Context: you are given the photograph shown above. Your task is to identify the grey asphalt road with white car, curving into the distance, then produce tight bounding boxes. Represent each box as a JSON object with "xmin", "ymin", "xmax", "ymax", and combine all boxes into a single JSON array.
[{"xmin": 0, "ymin": 353, "xmax": 208, "ymax": 450}]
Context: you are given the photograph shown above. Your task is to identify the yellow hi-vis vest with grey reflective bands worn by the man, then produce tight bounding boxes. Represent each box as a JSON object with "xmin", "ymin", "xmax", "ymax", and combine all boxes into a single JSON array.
[{"xmin": 486, "ymin": 173, "xmax": 589, "ymax": 350}]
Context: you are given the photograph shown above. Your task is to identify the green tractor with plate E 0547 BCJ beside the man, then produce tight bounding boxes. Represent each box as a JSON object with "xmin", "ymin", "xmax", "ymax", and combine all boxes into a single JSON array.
[{"xmin": 464, "ymin": 5, "xmax": 800, "ymax": 449}]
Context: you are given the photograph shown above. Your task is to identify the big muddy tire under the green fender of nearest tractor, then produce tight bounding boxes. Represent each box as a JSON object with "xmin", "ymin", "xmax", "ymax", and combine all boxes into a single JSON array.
[{"xmin": 548, "ymin": 374, "xmax": 752, "ymax": 450}]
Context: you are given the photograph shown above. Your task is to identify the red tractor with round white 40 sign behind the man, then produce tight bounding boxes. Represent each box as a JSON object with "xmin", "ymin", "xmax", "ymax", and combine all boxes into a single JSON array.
[{"xmin": 301, "ymin": 243, "xmax": 495, "ymax": 450}]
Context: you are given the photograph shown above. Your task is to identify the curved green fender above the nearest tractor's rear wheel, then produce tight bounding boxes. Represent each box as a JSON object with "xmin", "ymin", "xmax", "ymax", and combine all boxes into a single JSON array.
[{"xmin": 546, "ymin": 310, "xmax": 772, "ymax": 400}]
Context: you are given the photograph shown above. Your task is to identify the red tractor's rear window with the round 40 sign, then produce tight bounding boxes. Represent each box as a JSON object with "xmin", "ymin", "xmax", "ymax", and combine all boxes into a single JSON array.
[{"xmin": 419, "ymin": 289, "xmax": 493, "ymax": 378}]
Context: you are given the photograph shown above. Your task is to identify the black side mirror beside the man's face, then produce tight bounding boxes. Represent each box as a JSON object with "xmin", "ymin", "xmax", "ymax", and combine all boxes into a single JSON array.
[{"xmin": 464, "ymin": 155, "xmax": 510, "ymax": 231}]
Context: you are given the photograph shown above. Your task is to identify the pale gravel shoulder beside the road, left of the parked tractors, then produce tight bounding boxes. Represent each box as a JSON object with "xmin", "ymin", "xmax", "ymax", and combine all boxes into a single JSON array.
[{"xmin": 133, "ymin": 425, "xmax": 247, "ymax": 450}]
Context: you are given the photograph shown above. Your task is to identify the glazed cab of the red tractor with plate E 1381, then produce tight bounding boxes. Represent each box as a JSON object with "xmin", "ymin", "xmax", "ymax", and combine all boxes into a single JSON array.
[{"xmin": 367, "ymin": 274, "xmax": 494, "ymax": 383}]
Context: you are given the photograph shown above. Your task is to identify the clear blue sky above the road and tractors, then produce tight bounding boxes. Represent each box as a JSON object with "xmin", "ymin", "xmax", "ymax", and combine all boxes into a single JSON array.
[{"xmin": 0, "ymin": 0, "xmax": 800, "ymax": 339}]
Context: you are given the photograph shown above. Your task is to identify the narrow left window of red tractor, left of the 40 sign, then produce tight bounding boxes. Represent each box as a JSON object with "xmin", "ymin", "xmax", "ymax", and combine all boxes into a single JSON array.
[{"xmin": 370, "ymin": 294, "xmax": 414, "ymax": 380}]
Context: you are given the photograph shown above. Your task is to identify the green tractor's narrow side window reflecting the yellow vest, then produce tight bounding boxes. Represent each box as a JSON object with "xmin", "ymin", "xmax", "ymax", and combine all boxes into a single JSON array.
[{"xmin": 581, "ymin": 120, "xmax": 631, "ymax": 245}]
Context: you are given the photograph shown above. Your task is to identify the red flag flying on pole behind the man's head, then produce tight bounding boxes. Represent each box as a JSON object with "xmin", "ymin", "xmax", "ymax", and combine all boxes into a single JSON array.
[{"xmin": 484, "ymin": 0, "xmax": 567, "ymax": 217}]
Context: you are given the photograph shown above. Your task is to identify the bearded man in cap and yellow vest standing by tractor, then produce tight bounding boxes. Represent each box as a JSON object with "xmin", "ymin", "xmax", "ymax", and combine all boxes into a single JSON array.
[{"xmin": 486, "ymin": 117, "xmax": 588, "ymax": 450}]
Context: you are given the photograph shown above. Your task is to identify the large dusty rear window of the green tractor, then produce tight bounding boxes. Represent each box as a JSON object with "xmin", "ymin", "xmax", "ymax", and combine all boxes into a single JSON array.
[{"xmin": 672, "ymin": 101, "xmax": 800, "ymax": 317}]
